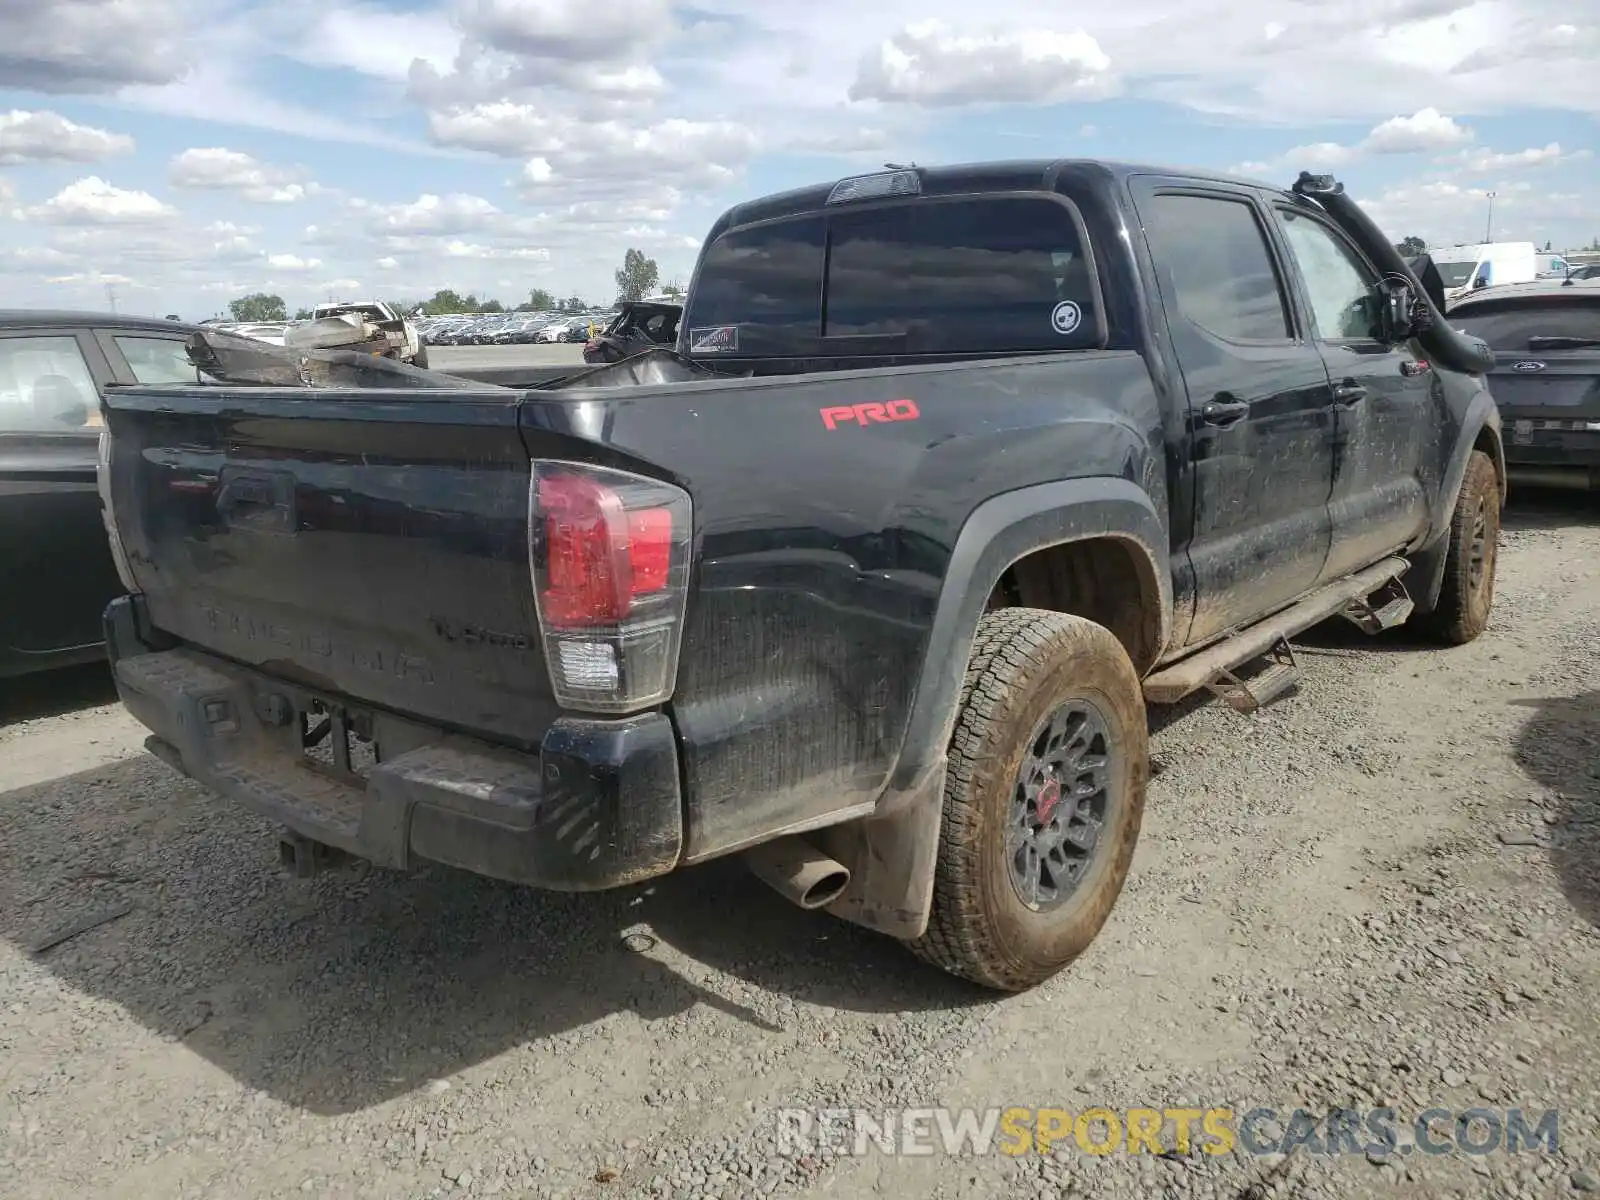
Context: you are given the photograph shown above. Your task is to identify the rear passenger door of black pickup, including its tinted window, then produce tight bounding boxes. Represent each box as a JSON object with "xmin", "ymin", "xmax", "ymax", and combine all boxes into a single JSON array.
[{"xmin": 1133, "ymin": 176, "xmax": 1334, "ymax": 643}]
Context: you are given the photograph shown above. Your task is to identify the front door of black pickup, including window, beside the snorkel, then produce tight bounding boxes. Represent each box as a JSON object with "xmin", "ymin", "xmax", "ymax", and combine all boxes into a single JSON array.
[{"xmin": 1277, "ymin": 205, "xmax": 1443, "ymax": 579}]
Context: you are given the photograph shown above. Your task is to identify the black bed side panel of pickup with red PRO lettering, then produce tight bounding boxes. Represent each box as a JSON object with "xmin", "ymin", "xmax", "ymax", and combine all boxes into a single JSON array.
[{"xmin": 523, "ymin": 352, "xmax": 1168, "ymax": 861}]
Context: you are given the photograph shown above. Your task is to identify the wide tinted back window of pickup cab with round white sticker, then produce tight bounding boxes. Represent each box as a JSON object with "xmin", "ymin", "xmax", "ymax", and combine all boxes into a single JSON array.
[{"xmin": 683, "ymin": 197, "xmax": 1099, "ymax": 355}]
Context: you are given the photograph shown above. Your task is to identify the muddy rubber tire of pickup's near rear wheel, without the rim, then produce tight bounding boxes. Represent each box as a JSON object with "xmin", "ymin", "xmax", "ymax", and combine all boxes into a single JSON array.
[{"xmin": 907, "ymin": 608, "xmax": 1149, "ymax": 992}]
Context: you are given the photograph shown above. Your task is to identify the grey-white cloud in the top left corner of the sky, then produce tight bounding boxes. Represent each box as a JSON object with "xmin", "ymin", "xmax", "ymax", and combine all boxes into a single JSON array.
[{"xmin": 0, "ymin": 0, "xmax": 198, "ymax": 94}]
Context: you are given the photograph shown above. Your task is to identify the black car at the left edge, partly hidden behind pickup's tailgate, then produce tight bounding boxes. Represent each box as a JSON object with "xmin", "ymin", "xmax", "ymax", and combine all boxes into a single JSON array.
[{"xmin": 0, "ymin": 310, "xmax": 197, "ymax": 677}]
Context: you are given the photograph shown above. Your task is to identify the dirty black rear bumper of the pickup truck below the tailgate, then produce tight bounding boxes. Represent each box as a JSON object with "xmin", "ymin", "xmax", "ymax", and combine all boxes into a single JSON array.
[{"xmin": 106, "ymin": 597, "xmax": 683, "ymax": 891}]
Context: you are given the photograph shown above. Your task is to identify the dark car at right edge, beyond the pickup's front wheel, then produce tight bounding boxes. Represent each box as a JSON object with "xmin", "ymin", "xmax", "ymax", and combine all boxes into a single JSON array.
[{"xmin": 1450, "ymin": 280, "xmax": 1600, "ymax": 488}]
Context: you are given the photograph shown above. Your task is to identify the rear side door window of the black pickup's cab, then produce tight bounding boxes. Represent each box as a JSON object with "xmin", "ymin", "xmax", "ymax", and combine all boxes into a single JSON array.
[{"xmin": 1146, "ymin": 195, "xmax": 1291, "ymax": 341}]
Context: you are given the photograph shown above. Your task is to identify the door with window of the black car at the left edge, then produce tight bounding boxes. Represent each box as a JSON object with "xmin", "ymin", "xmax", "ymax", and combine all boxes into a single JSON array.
[{"xmin": 0, "ymin": 326, "xmax": 122, "ymax": 670}]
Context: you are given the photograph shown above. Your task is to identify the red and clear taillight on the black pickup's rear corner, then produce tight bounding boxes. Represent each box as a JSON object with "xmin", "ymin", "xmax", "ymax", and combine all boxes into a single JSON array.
[{"xmin": 528, "ymin": 461, "xmax": 691, "ymax": 712}]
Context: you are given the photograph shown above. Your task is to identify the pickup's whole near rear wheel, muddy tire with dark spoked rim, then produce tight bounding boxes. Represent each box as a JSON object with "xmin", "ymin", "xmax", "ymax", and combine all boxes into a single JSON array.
[{"xmin": 909, "ymin": 608, "xmax": 1149, "ymax": 992}]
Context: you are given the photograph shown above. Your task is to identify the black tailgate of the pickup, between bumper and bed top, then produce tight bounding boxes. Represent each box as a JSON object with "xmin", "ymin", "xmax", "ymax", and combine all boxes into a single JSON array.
[{"xmin": 107, "ymin": 387, "xmax": 555, "ymax": 746}]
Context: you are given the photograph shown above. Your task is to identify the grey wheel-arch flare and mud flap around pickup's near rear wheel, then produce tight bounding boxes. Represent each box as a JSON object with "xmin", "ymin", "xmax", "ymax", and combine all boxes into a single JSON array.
[{"xmin": 818, "ymin": 477, "xmax": 1173, "ymax": 938}]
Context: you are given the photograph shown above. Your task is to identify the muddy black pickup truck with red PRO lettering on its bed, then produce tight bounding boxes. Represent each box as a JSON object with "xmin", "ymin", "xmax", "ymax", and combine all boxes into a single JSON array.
[{"xmin": 102, "ymin": 160, "xmax": 1504, "ymax": 990}]
